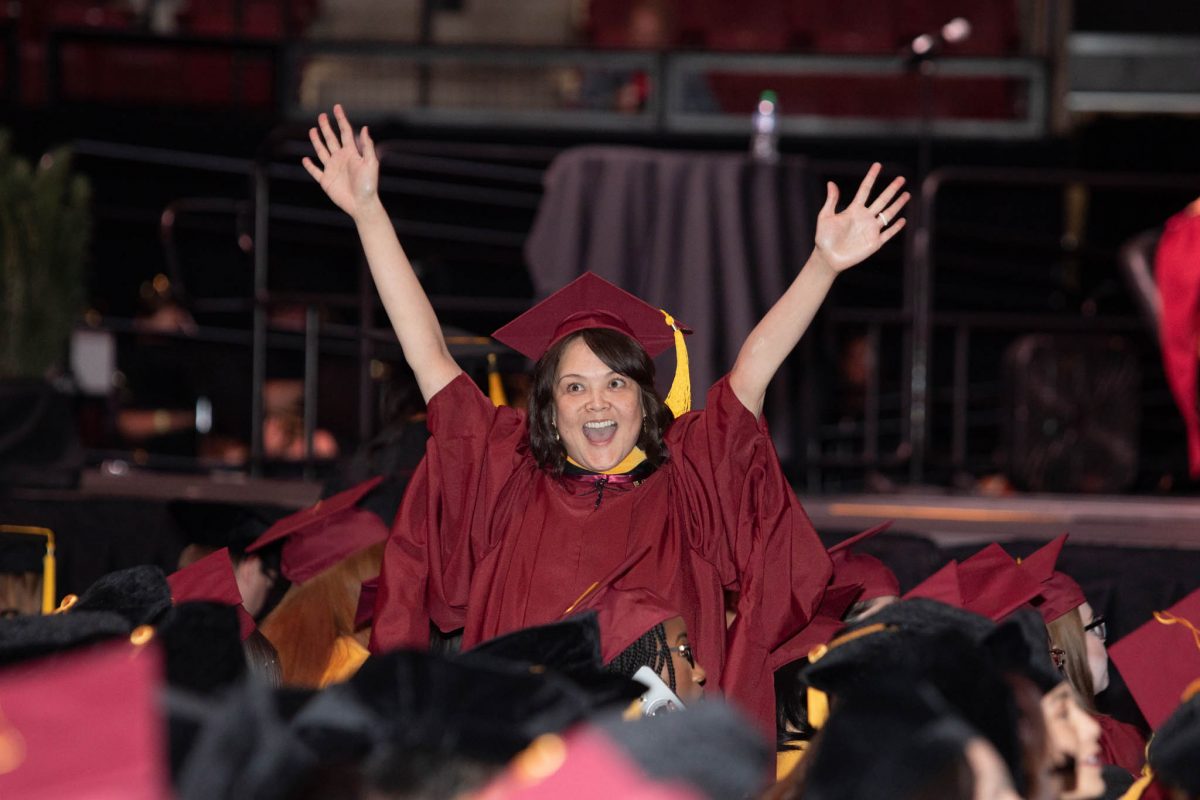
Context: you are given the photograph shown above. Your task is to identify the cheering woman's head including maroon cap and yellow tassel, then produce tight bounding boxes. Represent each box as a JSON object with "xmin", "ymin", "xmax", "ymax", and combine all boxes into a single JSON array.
[{"xmin": 492, "ymin": 272, "xmax": 691, "ymax": 474}]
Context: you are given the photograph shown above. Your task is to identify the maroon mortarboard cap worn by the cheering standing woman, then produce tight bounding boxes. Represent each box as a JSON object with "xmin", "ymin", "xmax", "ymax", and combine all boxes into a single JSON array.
[{"xmin": 492, "ymin": 272, "xmax": 691, "ymax": 361}]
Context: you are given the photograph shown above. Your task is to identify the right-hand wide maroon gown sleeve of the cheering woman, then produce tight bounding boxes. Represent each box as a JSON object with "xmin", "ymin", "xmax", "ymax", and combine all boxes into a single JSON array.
[{"xmin": 667, "ymin": 377, "xmax": 833, "ymax": 724}]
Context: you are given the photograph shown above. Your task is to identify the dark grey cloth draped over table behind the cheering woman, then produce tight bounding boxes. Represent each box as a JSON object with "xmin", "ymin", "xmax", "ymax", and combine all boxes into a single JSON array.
[{"xmin": 526, "ymin": 146, "xmax": 815, "ymax": 458}]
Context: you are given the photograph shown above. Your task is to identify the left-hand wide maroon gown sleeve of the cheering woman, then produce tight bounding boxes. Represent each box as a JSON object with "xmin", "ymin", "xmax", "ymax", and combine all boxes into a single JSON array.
[{"xmin": 371, "ymin": 373, "xmax": 527, "ymax": 652}]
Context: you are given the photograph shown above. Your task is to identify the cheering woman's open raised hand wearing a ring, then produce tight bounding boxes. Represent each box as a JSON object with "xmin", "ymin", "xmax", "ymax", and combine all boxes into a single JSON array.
[{"xmin": 816, "ymin": 163, "xmax": 910, "ymax": 272}]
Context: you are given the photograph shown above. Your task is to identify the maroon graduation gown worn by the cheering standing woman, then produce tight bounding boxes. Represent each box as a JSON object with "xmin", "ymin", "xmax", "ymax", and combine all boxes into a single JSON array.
[{"xmin": 371, "ymin": 374, "xmax": 830, "ymax": 735}]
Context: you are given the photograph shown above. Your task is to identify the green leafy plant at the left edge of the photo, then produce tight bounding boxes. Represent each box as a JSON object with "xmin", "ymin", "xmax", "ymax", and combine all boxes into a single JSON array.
[{"xmin": 0, "ymin": 131, "xmax": 91, "ymax": 378}]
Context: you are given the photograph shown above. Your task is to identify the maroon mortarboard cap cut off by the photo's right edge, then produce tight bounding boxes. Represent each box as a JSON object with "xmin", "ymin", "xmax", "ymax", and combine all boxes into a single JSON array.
[{"xmin": 1109, "ymin": 589, "xmax": 1200, "ymax": 728}]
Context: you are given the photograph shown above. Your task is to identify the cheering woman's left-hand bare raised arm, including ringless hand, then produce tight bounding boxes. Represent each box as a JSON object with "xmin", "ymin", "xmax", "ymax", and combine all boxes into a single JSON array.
[{"xmin": 302, "ymin": 106, "xmax": 462, "ymax": 401}]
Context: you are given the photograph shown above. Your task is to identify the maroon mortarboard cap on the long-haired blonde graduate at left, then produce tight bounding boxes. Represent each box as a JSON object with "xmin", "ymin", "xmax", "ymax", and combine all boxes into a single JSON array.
[{"xmin": 246, "ymin": 476, "xmax": 388, "ymax": 583}]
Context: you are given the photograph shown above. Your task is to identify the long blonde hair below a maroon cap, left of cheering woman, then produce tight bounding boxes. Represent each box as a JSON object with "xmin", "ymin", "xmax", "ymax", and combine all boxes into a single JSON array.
[{"xmin": 259, "ymin": 542, "xmax": 384, "ymax": 688}]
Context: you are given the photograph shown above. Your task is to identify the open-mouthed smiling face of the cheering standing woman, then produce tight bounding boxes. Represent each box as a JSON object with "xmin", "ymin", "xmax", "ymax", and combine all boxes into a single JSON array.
[{"xmin": 554, "ymin": 338, "xmax": 643, "ymax": 473}]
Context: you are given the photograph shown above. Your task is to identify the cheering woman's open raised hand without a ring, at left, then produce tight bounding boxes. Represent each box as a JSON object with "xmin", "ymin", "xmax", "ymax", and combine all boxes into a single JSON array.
[{"xmin": 301, "ymin": 104, "xmax": 379, "ymax": 217}]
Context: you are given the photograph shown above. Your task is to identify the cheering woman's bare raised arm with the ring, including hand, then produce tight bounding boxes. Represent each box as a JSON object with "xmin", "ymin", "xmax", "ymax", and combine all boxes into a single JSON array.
[{"xmin": 730, "ymin": 163, "xmax": 908, "ymax": 416}]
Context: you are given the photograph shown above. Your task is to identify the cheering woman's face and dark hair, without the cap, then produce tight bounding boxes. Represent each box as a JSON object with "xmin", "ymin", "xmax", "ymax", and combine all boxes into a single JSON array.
[{"xmin": 529, "ymin": 327, "xmax": 672, "ymax": 474}]
